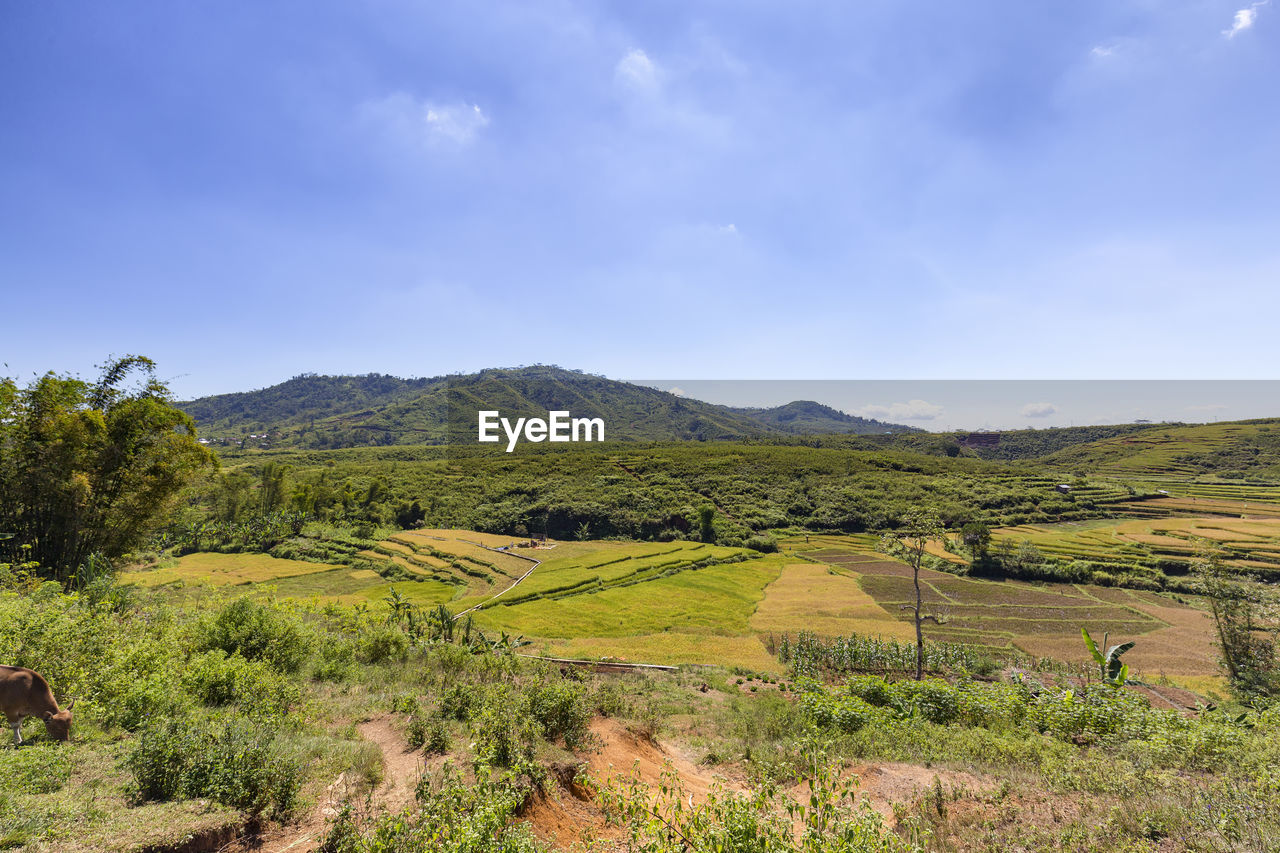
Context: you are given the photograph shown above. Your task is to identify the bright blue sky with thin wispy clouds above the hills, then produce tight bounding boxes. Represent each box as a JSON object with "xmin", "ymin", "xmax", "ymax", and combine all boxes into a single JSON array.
[{"xmin": 0, "ymin": 0, "xmax": 1280, "ymax": 399}]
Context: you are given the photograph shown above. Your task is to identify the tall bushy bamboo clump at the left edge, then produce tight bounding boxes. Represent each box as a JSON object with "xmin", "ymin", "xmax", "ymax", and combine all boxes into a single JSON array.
[{"xmin": 0, "ymin": 356, "xmax": 216, "ymax": 583}]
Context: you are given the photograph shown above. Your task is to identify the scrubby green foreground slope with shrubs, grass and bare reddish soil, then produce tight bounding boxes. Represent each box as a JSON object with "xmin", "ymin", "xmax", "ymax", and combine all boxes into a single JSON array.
[{"xmin": 0, "ymin": 568, "xmax": 1280, "ymax": 850}]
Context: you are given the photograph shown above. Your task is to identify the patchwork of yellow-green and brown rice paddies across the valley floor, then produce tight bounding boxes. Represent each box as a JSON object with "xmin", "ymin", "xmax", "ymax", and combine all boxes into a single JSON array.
[{"xmin": 125, "ymin": 519, "xmax": 1223, "ymax": 686}]
